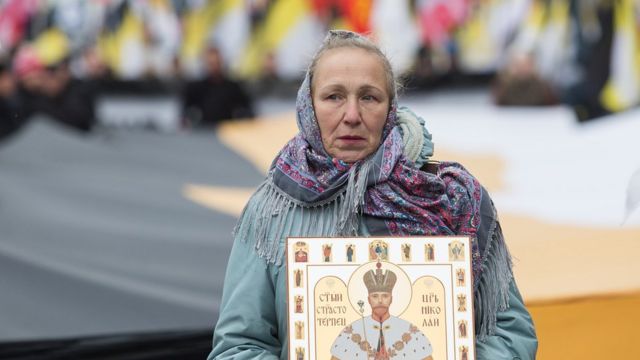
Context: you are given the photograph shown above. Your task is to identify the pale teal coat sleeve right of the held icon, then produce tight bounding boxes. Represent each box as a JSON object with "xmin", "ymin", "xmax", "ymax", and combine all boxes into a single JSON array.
[{"xmin": 476, "ymin": 281, "xmax": 538, "ymax": 360}]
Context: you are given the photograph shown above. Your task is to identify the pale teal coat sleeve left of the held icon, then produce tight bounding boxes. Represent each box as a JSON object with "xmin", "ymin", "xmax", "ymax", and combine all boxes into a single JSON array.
[{"xmin": 208, "ymin": 239, "xmax": 282, "ymax": 360}]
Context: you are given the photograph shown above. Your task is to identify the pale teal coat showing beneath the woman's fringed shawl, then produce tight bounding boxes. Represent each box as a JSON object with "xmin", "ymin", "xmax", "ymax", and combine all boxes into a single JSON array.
[{"xmin": 208, "ymin": 191, "xmax": 538, "ymax": 360}]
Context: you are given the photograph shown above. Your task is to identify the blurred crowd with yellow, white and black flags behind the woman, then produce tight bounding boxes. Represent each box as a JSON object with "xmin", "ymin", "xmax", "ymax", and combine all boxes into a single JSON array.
[{"xmin": 0, "ymin": 0, "xmax": 640, "ymax": 141}]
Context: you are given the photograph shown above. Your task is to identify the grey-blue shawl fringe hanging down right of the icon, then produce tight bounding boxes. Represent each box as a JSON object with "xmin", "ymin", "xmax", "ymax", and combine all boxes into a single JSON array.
[{"xmin": 474, "ymin": 220, "xmax": 513, "ymax": 341}]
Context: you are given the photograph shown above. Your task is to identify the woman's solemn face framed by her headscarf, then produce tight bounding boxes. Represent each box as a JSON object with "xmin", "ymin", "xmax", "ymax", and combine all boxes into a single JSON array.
[{"xmin": 311, "ymin": 47, "xmax": 390, "ymax": 163}]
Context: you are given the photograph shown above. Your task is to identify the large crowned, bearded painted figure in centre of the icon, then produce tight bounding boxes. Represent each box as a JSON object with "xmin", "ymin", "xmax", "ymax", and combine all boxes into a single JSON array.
[{"xmin": 331, "ymin": 262, "xmax": 433, "ymax": 360}]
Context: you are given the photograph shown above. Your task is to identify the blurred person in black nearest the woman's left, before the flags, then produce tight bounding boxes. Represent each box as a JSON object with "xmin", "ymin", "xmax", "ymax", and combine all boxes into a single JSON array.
[{"xmin": 183, "ymin": 46, "xmax": 254, "ymax": 126}]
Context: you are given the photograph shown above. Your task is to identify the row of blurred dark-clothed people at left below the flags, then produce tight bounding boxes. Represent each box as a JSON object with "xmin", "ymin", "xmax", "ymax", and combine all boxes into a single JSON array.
[{"xmin": 0, "ymin": 25, "xmax": 254, "ymax": 139}]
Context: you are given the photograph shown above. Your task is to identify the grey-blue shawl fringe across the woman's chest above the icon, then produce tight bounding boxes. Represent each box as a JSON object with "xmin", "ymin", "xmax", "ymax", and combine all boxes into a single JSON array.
[{"xmin": 233, "ymin": 159, "xmax": 373, "ymax": 265}]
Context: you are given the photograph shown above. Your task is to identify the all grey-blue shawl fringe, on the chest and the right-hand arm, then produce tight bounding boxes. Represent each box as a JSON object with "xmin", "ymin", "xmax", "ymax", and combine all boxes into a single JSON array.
[{"xmin": 233, "ymin": 161, "xmax": 513, "ymax": 341}]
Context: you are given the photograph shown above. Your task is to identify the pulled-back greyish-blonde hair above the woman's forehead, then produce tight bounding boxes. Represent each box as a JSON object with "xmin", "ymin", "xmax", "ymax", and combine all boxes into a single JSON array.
[{"xmin": 309, "ymin": 30, "xmax": 399, "ymax": 99}]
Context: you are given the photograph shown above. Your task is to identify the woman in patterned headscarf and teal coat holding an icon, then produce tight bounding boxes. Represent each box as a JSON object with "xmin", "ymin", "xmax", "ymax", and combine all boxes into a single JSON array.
[{"xmin": 209, "ymin": 31, "xmax": 537, "ymax": 360}]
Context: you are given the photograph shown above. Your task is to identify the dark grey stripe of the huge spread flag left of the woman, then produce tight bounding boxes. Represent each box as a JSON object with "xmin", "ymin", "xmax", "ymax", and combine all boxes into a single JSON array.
[{"xmin": 0, "ymin": 121, "xmax": 261, "ymax": 341}]
